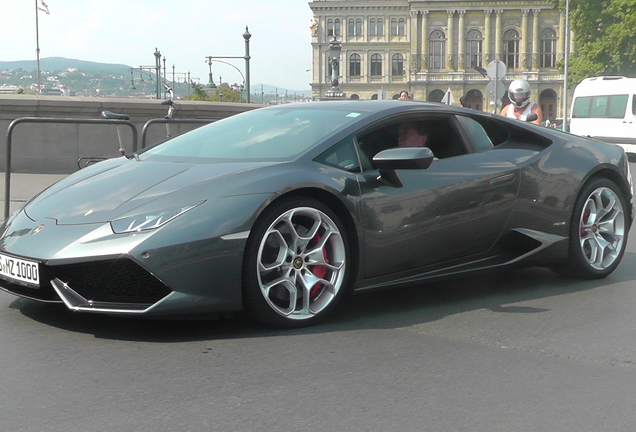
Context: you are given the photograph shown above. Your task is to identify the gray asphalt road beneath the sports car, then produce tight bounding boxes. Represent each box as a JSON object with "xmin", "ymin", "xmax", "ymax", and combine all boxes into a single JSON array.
[{"xmin": 0, "ymin": 170, "xmax": 636, "ymax": 432}]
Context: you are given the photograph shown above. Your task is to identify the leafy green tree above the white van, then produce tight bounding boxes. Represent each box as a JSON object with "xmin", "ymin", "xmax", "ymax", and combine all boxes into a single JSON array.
[{"xmin": 554, "ymin": 0, "xmax": 636, "ymax": 84}]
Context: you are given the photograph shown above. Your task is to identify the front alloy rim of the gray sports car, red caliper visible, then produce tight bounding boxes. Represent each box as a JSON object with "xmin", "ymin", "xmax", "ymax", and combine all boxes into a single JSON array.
[{"xmin": 257, "ymin": 207, "xmax": 346, "ymax": 320}]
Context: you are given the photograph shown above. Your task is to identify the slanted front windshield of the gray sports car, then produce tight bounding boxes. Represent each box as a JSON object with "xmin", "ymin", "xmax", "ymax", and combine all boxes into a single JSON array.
[{"xmin": 142, "ymin": 104, "xmax": 369, "ymax": 161}]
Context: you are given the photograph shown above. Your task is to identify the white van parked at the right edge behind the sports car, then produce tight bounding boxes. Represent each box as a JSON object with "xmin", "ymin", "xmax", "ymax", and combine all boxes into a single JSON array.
[{"xmin": 570, "ymin": 76, "xmax": 636, "ymax": 157}]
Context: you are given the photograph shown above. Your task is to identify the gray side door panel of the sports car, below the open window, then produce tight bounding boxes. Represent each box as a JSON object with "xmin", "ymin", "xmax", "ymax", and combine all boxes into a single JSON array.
[{"xmin": 360, "ymin": 116, "xmax": 520, "ymax": 277}]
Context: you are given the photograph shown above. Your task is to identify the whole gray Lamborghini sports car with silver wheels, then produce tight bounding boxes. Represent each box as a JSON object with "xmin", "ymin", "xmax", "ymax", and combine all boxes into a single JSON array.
[{"xmin": 0, "ymin": 101, "xmax": 634, "ymax": 327}]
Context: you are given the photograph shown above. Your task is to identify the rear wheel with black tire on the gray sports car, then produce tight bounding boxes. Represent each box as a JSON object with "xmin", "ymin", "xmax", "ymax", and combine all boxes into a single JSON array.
[{"xmin": 555, "ymin": 178, "xmax": 629, "ymax": 279}]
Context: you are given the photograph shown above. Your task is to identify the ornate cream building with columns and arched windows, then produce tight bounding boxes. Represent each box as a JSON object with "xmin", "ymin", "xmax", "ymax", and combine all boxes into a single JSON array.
[{"xmin": 309, "ymin": 0, "xmax": 573, "ymax": 120}]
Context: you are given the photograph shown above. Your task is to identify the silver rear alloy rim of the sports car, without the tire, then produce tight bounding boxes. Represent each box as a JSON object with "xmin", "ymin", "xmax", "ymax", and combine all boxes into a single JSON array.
[{"xmin": 579, "ymin": 187, "xmax": 625, "ymax": 270}]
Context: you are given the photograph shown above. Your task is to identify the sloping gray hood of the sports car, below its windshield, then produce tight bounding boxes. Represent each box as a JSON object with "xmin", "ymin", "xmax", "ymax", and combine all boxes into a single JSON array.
[{"xmin": 24, "ymin": 159, "xmax": 272, "ymax": 225}]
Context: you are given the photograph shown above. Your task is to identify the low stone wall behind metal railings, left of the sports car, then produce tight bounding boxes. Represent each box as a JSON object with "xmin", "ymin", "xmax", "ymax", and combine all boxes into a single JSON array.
[{"xmin": 0, "ymin": 95, "xmax": 262, "ymax": 174}]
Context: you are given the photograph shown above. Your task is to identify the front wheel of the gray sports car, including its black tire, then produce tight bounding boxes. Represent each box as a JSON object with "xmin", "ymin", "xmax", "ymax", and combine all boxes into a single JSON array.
[{"xmin": 243, "ymin": 197, "xmax": 351, "ymax": 328}]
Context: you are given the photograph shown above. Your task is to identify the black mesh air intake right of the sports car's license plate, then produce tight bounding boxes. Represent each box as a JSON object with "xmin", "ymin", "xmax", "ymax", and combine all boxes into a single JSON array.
[{"xmin": 49, "ymin": 259, "xmax": 170, "ymax": 303}]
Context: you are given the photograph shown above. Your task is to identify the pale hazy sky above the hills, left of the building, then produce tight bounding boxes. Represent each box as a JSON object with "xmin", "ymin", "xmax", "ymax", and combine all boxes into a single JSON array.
[{"xmin": 0, "ymin": 0, "xmax": 312, "ymax": 90}]
